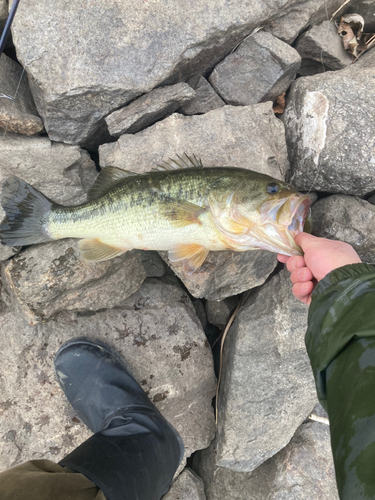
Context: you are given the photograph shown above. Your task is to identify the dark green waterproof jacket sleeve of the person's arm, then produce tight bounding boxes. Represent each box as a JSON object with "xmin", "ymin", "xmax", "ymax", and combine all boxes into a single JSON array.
[{"xmin": 305, "ymin": 264, "xmax": 375, "ymax": 500}]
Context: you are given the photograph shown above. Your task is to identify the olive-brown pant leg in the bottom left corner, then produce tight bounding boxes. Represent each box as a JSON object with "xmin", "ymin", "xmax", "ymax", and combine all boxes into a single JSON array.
[{"xmin": 0, "ymin": 460, "xmax": 106, "ymax": 500}]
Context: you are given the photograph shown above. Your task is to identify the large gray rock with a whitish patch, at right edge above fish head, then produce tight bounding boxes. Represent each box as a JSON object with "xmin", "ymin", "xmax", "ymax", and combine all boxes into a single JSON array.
[{"xmin": 284, "ymin": 51, "xmax": 375, "ymax": 196}]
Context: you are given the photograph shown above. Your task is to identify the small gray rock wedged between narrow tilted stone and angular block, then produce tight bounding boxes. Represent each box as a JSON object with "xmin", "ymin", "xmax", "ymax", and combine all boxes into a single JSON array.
[{"xmin": 179, "ymin": 75, "xmax": 225, "ymax": 115}]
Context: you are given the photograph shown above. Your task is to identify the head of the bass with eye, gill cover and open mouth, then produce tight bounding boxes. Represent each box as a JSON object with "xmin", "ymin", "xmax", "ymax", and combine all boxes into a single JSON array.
[{"xmin": 212, "ymin": 174, "xmax": 313, "ymax": 256}]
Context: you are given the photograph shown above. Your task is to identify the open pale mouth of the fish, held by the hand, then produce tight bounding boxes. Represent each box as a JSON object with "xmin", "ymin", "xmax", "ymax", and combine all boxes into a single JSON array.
[{"xmin": 260, "ymin": 194, "xmax": 313, "ymax": 256}]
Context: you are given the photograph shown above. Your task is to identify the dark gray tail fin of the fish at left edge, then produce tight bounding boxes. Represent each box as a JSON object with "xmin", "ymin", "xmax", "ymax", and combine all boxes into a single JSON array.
[{"xmin": 0, "ymin": 176, "xmax": 53, "ymax": 246}]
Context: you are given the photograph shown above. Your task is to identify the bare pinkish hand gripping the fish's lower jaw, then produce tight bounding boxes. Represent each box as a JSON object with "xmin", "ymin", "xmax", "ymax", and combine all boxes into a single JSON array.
[{"xmin": 277, "ymin": 233, "xmax": 362, "ymax": 305}]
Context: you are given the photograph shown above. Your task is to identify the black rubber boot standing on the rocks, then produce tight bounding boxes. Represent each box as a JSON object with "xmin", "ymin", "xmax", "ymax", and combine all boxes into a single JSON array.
[{"xmin": 55, "ymin": 338, "xmax": 184, "ymax": 500}]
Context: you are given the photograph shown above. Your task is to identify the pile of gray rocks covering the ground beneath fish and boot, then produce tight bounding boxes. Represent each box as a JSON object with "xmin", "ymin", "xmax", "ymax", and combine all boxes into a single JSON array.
[{"xmin": 0, "ymin": 0, "xmax": 375, "ymax": 500}]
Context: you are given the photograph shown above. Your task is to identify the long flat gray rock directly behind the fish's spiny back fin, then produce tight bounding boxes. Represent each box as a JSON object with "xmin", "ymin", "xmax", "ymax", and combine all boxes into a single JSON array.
[{"xmin": 99, "ymin": 103, "xmax": 289, "ymax": 179}]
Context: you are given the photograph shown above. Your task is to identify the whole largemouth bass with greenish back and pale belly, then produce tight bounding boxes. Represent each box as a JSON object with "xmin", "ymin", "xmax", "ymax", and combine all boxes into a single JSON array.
[{"xmin": 0, "ymin": 153, "xmax": 312, "ymax": 275}]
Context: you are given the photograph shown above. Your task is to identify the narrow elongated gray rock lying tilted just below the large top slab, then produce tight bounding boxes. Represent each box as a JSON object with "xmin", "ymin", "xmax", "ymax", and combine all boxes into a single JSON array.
[{"xmin": 105, "ymin": 83, "xmax": 195, "ymax": 137}]
